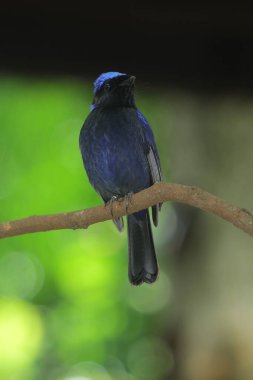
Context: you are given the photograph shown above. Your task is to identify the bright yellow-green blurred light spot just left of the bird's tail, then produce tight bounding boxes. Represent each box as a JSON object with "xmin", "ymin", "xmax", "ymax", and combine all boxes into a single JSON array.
[{"xmin": 54, "ymin": 225, "xmax": 125, "ymax": 297}]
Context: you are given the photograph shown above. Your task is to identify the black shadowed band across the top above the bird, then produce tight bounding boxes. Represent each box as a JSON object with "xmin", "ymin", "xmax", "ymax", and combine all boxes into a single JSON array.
[{"xmin": 0, "ymin": 1, "xmax": 253, "ymax": 91}]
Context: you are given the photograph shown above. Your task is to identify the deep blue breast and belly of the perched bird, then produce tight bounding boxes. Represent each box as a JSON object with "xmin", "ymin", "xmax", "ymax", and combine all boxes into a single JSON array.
[{"xmin": 81, "ymin": 109, "xmax": 150, "ymax": 195}]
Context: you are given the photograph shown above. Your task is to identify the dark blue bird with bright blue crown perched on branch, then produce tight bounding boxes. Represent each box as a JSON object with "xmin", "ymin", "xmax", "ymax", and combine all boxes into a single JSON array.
[{"xmin": 79, "ymin": 71, "xmax": 162, "ymax": 285}]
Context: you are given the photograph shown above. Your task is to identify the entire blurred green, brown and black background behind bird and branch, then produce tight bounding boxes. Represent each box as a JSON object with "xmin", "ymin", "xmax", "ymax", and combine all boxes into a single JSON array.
[{"xmin": 0, "ymin": 0, "xmax": 253, "ymax": 380}]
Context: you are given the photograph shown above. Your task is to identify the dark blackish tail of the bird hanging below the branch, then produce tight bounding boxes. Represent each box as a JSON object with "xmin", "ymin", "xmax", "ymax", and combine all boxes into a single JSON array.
[{"xmin": 127, "ymin": 210, "xmax": 158, "ymax": 285}]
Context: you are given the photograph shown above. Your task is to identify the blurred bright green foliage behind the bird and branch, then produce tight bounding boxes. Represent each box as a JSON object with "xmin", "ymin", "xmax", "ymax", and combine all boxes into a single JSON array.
[{"xmin": 0, "ymin": 76, "xmax": 172, "ymax": 380}]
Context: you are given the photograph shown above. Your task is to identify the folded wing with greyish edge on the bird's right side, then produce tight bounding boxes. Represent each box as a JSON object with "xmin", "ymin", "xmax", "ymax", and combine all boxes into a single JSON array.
[{"xmin": 137, "ymin": 110, "xmax": 162, "ymax": 226}]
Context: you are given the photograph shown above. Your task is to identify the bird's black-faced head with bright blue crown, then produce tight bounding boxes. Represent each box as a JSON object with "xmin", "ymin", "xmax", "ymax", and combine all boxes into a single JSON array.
[{"xmin": 92, "ymin": 71, "xmax": 135, "ymax": 109}]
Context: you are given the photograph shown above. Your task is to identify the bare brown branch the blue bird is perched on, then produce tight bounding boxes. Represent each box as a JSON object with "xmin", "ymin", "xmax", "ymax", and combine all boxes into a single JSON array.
[{"xmin": 0, "ymin": 183, "xmax": 253, "ymax": 239}]
